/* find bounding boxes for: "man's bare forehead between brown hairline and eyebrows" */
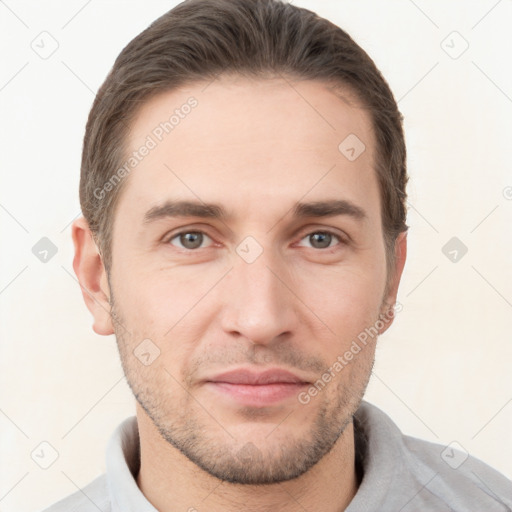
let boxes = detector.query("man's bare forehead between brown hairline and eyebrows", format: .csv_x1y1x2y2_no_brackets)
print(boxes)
118,75,375,222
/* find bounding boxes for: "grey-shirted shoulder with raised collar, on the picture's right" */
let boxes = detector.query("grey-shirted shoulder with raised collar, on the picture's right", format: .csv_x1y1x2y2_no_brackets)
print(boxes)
354,402,512,512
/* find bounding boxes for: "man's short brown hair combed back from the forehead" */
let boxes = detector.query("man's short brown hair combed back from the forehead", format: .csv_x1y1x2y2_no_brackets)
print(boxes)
80,0,408,275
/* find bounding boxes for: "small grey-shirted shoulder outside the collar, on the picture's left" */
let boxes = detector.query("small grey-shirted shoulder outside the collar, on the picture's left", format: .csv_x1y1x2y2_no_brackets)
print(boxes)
42,474,111,512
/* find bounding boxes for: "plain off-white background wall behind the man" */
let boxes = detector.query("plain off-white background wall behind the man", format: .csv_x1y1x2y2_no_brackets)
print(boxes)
0,0,512,512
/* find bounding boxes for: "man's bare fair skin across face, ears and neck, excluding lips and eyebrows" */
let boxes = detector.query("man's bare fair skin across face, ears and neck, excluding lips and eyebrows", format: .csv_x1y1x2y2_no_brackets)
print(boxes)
73,77,406,512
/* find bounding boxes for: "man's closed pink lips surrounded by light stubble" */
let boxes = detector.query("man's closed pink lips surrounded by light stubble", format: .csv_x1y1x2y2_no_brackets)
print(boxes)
204,368,310,407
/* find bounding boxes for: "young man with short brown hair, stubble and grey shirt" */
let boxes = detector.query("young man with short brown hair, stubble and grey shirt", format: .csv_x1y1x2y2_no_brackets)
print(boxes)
44,0,512,512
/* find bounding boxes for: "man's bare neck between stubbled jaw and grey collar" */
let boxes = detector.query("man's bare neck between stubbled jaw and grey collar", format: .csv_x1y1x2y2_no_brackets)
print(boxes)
137,404,358,512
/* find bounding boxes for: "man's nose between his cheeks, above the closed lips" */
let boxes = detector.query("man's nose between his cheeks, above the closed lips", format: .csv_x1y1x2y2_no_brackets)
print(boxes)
221,250,299,345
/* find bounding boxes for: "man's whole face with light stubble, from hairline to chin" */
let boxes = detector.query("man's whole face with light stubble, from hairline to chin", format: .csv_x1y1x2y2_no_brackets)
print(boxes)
102,77,404,484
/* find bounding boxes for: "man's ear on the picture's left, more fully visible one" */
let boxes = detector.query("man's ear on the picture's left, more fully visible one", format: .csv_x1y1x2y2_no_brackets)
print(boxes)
72,217,114,336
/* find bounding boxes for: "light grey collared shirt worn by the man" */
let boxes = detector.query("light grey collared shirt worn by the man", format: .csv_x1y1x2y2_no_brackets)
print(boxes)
44,402,512,512
